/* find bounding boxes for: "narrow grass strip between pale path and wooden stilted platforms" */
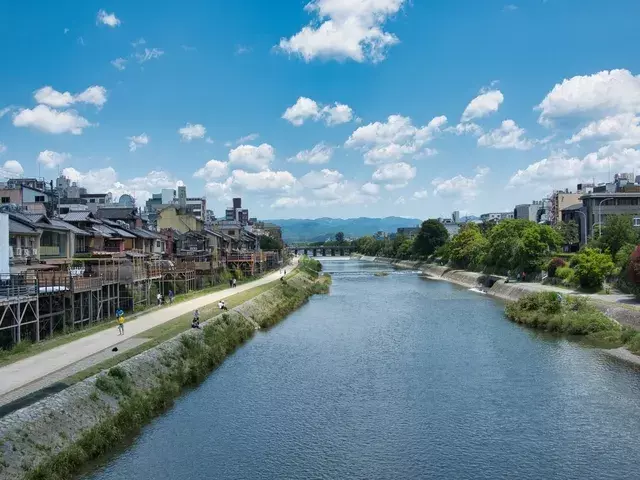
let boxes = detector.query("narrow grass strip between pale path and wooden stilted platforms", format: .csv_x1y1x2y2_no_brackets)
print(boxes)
0,272,282,367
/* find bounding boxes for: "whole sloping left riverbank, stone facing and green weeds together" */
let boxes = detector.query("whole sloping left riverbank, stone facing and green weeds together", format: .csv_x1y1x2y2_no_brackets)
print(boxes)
0,271,330,480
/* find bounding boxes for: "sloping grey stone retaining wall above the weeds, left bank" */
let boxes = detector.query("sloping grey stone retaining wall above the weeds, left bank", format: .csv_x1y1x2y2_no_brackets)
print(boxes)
0,272,324,480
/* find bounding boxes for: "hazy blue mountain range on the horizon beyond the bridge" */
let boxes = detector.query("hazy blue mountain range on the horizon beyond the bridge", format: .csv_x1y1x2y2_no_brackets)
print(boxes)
266,217,422,243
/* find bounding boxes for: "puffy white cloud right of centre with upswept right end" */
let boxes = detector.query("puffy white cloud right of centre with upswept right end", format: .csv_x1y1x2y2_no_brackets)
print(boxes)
345,115,447,165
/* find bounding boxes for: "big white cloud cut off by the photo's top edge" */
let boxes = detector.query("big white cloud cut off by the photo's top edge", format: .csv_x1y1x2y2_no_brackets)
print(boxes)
278,0,405,63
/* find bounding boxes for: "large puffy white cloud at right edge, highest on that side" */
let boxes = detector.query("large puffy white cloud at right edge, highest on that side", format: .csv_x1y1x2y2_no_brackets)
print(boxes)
536,70,640,125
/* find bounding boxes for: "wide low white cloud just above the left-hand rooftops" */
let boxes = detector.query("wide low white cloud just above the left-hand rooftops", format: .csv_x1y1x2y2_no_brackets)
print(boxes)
62,167,183,205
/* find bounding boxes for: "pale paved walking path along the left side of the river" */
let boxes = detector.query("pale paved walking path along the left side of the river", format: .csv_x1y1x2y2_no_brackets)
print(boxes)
0,267,291,397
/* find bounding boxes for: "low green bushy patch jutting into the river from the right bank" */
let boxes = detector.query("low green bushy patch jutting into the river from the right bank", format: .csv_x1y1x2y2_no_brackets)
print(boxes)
505,292,640,354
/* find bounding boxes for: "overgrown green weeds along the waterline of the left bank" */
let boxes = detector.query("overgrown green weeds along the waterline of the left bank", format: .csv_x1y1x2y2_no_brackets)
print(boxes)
24,270,331,480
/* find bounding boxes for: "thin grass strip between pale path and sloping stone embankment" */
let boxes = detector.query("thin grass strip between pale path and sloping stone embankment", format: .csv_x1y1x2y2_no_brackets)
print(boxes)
61,280,280,386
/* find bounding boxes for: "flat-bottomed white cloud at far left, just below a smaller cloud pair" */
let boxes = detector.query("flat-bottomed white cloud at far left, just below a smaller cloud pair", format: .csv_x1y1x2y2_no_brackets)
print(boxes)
13,105,92,135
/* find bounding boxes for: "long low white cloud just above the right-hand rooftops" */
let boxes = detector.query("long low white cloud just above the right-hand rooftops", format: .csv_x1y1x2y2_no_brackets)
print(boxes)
508,146,640,189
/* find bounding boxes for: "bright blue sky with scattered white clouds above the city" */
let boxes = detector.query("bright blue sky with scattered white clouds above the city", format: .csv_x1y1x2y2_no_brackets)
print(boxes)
0,0,640,218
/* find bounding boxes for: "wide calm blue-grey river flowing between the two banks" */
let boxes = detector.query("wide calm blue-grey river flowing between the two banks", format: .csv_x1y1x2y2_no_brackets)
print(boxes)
85,259,640,480
